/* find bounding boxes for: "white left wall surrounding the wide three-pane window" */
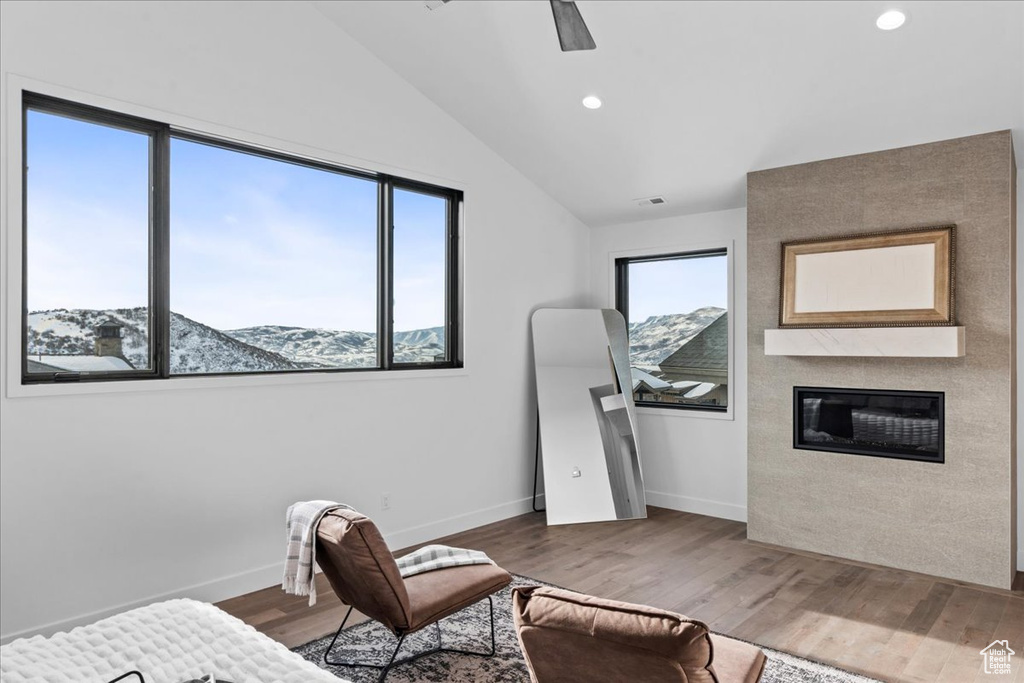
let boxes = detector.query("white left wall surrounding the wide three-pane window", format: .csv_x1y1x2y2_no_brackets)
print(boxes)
0,2,589,640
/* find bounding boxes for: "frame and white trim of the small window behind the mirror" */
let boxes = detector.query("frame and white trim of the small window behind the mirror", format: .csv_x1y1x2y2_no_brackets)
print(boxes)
611,244,735,419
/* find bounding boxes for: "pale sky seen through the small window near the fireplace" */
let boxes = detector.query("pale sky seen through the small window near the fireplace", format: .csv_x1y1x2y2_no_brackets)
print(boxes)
629,256,729,323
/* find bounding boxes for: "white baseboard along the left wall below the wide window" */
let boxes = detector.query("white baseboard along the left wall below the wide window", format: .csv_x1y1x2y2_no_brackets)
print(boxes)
0,496,543,644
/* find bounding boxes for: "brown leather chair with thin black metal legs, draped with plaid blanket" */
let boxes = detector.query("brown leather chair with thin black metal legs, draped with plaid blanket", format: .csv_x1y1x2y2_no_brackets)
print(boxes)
316,509,512,681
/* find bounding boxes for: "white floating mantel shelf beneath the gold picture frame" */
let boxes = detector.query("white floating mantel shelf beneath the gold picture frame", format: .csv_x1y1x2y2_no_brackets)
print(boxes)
765,327,965,358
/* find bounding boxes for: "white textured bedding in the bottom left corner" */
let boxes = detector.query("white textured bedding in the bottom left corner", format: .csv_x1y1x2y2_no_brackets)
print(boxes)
0,600,344,683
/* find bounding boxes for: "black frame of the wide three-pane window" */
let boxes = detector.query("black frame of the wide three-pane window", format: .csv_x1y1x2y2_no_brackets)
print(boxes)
18,89,464,386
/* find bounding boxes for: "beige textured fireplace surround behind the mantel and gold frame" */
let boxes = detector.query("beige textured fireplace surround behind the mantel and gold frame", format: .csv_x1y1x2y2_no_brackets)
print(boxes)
748,131,1016,589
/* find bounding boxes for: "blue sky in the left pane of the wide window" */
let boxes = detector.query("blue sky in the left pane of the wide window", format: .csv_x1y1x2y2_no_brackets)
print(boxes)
27,113,150,317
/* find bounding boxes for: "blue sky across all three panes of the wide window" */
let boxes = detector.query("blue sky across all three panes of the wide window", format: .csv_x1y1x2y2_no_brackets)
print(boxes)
28,112,444,332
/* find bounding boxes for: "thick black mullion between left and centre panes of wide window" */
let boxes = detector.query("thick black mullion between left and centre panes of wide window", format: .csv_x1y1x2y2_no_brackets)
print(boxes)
150,126,171,378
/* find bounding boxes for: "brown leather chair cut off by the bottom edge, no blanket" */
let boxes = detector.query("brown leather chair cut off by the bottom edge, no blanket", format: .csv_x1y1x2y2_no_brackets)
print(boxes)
512,586,765,683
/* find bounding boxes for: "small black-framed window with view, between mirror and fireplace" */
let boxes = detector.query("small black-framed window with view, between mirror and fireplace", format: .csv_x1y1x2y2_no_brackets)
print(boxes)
615,249,729,412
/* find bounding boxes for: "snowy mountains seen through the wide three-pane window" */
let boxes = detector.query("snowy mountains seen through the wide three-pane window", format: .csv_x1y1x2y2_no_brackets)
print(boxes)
29,307,444,374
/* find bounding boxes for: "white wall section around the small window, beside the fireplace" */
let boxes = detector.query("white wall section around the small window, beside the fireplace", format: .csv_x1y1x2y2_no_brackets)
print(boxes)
591,209,746,521
